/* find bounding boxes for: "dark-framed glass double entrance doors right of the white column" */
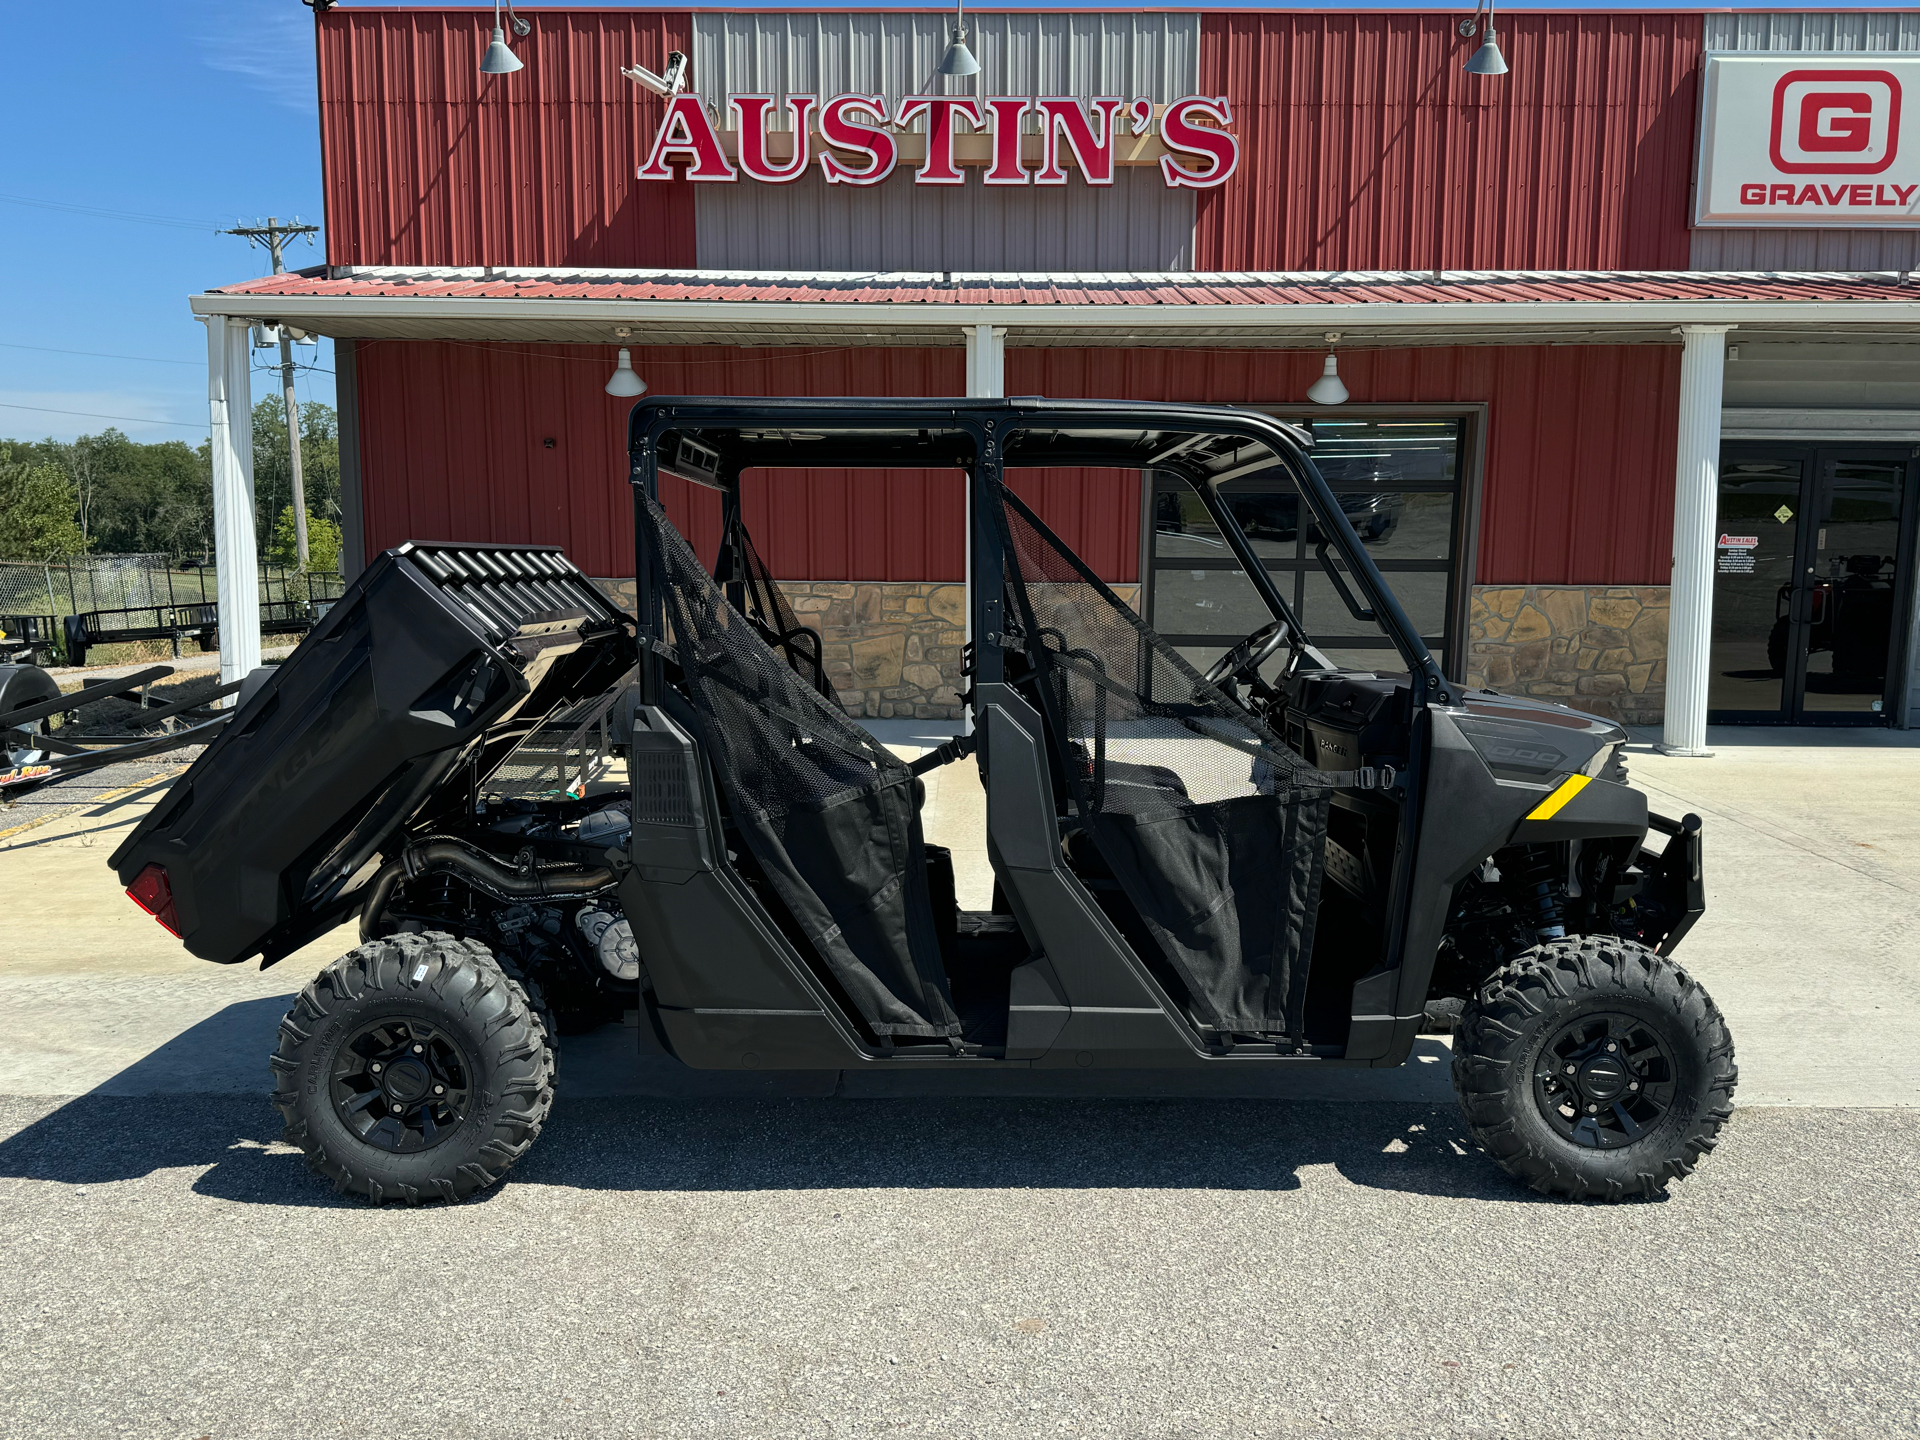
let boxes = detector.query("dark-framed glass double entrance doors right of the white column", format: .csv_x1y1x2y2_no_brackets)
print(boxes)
1708,444,1915,724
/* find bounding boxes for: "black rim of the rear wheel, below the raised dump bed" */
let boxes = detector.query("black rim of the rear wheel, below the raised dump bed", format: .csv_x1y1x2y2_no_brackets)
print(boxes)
332,1016,473,1155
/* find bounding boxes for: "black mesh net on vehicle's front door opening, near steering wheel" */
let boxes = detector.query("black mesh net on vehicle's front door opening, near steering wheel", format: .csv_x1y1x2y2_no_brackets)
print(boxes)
1001,490,1331,1043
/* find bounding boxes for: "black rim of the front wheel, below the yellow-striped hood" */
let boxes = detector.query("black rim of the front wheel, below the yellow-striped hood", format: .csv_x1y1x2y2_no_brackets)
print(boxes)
1535,1013,1675,1151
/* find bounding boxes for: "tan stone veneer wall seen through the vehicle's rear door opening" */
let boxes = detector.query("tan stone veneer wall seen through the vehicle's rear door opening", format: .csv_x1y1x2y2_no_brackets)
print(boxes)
594,580,1139,721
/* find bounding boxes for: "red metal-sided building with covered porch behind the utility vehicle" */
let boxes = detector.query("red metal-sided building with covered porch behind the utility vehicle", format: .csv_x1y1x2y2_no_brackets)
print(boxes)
196,6,1921,747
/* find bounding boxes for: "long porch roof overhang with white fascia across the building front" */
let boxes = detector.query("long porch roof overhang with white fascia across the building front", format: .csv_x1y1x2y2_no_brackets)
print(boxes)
192,290,1917,350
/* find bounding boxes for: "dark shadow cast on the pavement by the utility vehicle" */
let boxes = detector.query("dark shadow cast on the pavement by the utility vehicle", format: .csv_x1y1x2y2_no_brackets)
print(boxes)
0,997,1598,1207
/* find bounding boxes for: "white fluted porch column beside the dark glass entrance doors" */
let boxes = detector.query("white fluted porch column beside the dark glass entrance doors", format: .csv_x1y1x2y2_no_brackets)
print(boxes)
1660,325,1733,755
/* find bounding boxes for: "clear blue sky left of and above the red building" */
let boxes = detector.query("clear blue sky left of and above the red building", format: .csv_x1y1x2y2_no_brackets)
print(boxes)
0,0,1877,442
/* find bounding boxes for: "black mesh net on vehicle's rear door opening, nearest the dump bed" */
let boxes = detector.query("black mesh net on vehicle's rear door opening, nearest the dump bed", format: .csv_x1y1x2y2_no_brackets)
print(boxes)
638,496,961,1038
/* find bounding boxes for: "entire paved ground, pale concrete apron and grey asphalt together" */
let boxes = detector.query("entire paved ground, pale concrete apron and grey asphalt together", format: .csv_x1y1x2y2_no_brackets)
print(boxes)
0,732,1921,1435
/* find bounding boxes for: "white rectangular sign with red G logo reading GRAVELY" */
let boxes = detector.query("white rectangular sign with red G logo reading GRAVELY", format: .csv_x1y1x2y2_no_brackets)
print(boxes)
1694,52,1921,231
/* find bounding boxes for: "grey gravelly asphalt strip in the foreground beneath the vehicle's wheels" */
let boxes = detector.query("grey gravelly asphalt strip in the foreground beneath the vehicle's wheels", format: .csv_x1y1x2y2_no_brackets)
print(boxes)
0,1095,1921,1437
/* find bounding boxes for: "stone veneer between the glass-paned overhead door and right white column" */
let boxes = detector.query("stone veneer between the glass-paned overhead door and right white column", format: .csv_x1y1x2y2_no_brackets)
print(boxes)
1466,586,1667,726
